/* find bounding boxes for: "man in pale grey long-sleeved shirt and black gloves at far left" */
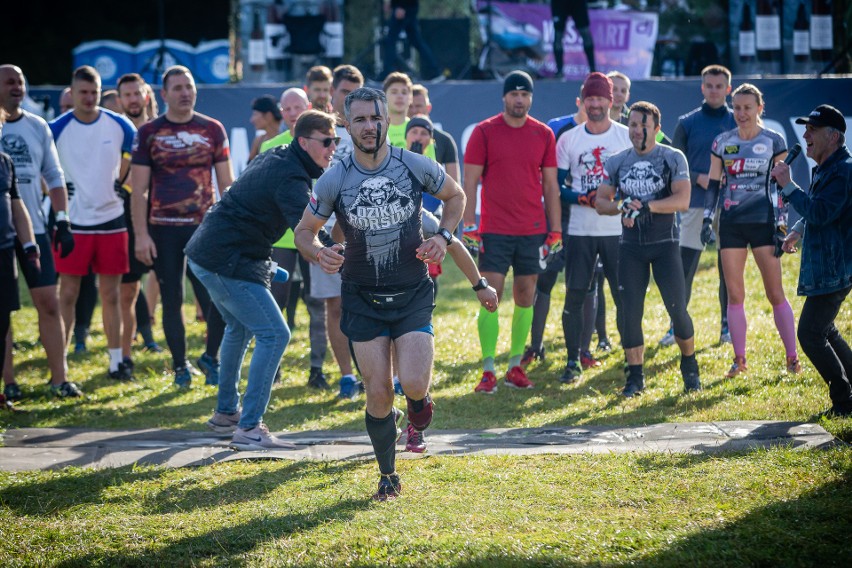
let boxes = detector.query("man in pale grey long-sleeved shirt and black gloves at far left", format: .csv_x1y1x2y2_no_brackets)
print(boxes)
0,65,80,401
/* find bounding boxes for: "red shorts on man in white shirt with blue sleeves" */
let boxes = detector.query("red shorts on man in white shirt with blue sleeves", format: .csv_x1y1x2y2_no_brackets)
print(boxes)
53,231,130,276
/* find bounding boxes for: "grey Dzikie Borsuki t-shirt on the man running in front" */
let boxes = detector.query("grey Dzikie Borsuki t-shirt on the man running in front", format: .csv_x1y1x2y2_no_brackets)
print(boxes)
310,147,446,288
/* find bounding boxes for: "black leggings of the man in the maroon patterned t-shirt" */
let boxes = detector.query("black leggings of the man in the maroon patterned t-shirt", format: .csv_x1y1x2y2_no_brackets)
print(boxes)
148,225,225,368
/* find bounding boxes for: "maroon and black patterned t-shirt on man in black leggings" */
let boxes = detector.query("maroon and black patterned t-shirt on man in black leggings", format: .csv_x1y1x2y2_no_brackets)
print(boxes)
132,113,230,226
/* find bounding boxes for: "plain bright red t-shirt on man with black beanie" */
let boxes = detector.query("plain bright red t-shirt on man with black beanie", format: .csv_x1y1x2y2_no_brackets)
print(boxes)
464,114,556,236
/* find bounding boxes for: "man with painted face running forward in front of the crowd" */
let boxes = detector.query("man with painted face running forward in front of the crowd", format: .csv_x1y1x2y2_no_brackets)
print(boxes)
296,88,465,501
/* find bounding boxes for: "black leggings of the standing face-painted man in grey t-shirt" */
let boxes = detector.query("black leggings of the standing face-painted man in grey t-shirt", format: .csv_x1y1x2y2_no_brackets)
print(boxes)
618,242,695,349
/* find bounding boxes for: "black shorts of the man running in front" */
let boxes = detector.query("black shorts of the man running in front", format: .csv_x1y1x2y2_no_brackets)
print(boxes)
340,278,435,342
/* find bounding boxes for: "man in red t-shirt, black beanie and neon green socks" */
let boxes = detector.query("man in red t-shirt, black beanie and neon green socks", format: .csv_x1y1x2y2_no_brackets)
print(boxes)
464,71,562,394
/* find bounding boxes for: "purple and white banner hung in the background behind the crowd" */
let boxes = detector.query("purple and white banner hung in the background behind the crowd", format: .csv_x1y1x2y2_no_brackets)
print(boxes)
477,0,659,79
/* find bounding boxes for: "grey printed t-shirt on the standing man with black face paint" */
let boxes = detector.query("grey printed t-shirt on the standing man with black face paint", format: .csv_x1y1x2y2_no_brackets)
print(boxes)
604,144,689,244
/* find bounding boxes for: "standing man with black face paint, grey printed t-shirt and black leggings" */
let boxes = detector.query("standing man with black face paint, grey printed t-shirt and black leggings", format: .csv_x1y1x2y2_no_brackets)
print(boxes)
595,102,701,397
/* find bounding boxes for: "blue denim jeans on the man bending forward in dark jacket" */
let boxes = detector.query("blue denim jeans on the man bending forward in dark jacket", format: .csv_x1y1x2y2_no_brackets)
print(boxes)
189,260,290,430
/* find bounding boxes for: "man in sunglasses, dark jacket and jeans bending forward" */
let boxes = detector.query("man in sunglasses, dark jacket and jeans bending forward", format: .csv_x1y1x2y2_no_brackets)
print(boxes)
186,110,340,450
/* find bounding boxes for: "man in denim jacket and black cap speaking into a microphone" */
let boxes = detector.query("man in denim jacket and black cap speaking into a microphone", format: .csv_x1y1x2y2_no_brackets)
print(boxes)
770,105,852,416
